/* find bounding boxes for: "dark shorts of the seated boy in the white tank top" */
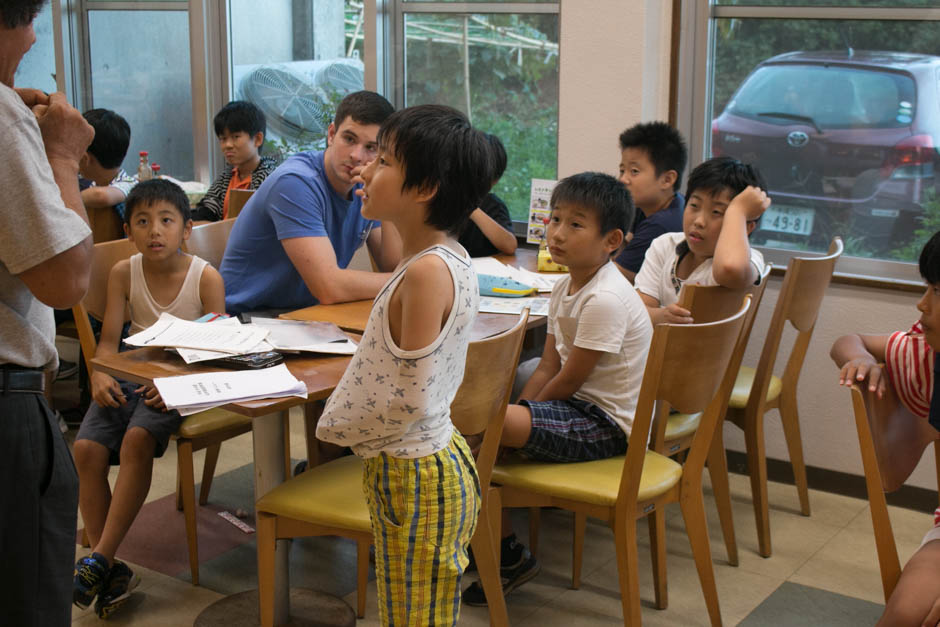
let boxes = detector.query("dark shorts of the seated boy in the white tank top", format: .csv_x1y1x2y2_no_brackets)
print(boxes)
75,381,183,465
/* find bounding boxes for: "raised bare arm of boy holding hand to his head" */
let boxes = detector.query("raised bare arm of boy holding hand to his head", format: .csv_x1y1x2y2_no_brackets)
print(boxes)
712,186,770,289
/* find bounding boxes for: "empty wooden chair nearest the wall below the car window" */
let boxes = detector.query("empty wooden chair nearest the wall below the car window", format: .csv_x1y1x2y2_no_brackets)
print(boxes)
725,237,842,557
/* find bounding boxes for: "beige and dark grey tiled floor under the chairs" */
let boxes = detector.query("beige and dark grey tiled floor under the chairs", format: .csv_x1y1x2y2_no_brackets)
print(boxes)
53,338,931,627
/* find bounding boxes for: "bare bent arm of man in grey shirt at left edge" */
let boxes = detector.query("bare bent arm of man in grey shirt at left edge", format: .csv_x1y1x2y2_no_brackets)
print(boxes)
19,94,95,309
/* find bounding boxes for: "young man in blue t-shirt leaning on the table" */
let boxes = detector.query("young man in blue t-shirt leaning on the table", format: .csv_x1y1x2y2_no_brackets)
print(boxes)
220,91,401,314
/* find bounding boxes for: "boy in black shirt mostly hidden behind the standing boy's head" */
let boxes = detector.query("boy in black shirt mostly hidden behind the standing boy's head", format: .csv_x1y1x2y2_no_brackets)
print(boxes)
457,133,516,257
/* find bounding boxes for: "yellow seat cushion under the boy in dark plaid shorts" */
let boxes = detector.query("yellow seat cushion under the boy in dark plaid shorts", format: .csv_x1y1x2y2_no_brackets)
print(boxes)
492,451,682,505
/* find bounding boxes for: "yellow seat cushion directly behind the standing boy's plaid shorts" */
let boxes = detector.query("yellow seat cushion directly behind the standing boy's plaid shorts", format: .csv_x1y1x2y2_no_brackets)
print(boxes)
255,455,372,532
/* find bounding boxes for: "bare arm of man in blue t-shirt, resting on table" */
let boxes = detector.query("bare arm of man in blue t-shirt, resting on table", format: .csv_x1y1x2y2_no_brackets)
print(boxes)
281,233,397,305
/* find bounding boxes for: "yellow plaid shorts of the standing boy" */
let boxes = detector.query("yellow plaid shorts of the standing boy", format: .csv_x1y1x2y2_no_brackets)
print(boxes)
362,431,480,626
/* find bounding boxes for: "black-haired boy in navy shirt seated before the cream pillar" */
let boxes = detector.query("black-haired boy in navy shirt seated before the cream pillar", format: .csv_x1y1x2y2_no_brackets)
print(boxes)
614,122,689,283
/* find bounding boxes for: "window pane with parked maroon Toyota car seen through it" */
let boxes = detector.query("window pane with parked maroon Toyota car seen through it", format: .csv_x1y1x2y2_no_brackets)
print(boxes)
711,18,940,261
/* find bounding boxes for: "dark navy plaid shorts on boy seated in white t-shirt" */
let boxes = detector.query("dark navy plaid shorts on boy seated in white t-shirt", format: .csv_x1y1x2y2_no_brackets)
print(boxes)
519,398,627,462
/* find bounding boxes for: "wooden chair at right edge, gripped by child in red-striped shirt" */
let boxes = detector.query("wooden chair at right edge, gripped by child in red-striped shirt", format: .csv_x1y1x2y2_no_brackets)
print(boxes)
852,381,940,603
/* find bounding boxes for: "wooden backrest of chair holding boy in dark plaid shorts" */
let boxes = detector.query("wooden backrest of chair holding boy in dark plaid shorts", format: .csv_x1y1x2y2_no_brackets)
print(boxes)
618,295,751,507
